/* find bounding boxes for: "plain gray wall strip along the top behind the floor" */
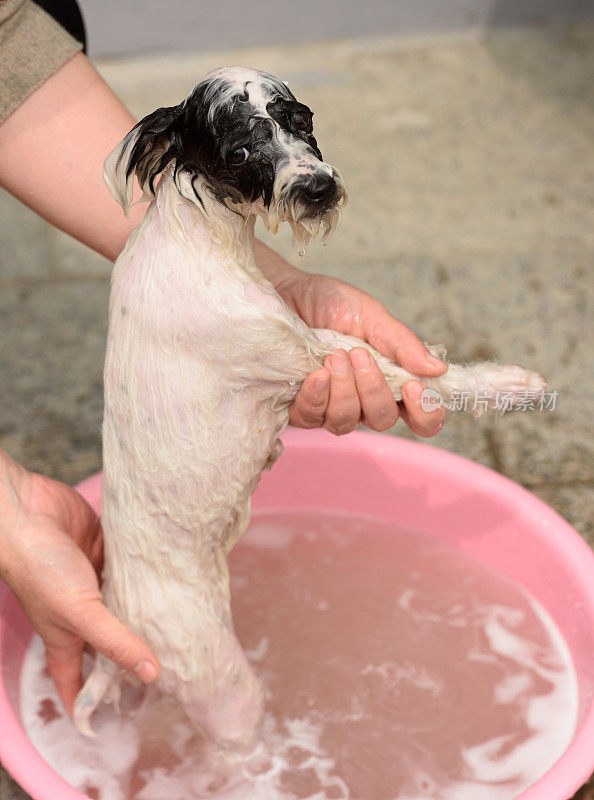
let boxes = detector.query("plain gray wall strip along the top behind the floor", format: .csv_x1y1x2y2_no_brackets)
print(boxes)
79,0,594,56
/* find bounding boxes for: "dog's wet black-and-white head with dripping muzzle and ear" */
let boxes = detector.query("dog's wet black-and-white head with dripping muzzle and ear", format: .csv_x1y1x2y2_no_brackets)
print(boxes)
105,67,346,246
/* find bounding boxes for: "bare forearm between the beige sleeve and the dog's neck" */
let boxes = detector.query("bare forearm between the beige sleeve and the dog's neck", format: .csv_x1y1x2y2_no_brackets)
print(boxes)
0,54,138,260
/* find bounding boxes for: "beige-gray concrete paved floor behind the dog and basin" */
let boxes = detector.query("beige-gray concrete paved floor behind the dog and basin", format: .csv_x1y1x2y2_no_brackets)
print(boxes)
0,24,594,800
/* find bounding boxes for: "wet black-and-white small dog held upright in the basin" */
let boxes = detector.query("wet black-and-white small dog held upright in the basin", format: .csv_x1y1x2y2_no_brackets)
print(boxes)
74,67,545,745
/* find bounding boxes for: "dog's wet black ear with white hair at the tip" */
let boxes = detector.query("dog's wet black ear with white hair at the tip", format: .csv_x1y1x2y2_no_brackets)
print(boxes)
103,105,184,216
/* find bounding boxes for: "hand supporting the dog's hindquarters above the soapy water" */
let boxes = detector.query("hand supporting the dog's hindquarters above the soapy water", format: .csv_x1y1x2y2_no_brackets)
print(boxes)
0,451,159,714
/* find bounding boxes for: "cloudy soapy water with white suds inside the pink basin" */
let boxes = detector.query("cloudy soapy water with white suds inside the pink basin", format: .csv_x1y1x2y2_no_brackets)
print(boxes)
21,512,577,800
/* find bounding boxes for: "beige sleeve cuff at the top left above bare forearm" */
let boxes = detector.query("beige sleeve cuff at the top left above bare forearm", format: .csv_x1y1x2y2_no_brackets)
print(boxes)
0,0,82,122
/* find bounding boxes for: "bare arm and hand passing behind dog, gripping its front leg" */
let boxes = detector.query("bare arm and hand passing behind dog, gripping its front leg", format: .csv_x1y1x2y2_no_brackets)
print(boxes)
0,54,446,436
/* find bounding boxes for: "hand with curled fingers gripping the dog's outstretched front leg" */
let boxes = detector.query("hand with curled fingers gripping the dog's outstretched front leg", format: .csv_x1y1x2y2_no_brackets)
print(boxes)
276,269,447,436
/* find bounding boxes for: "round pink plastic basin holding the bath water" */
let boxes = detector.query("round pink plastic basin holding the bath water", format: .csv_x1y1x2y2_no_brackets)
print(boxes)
0,430,594,800
